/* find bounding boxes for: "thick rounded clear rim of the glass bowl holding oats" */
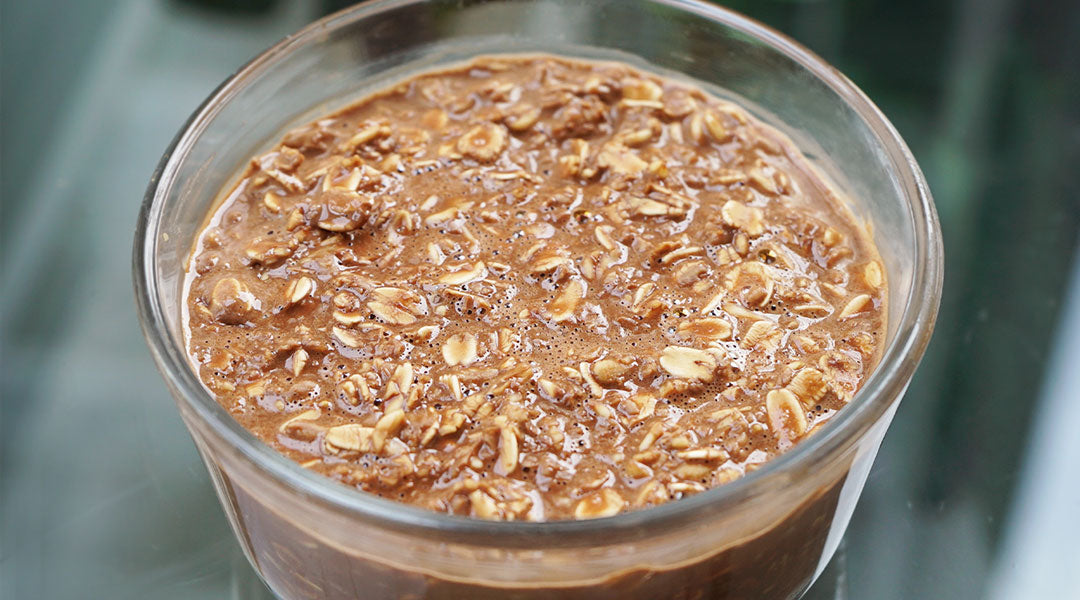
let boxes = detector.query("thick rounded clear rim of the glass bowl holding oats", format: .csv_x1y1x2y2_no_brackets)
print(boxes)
133,0,943,546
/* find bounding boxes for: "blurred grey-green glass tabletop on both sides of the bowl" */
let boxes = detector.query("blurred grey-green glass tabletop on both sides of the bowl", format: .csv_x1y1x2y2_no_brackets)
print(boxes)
0,0,1080,600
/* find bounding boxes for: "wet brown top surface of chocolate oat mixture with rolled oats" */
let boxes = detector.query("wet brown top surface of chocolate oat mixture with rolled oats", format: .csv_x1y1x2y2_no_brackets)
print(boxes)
187,57,885,520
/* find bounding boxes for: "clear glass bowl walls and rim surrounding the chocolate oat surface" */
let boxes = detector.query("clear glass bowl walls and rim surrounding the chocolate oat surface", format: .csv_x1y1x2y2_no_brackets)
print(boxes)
134,0,942,600
